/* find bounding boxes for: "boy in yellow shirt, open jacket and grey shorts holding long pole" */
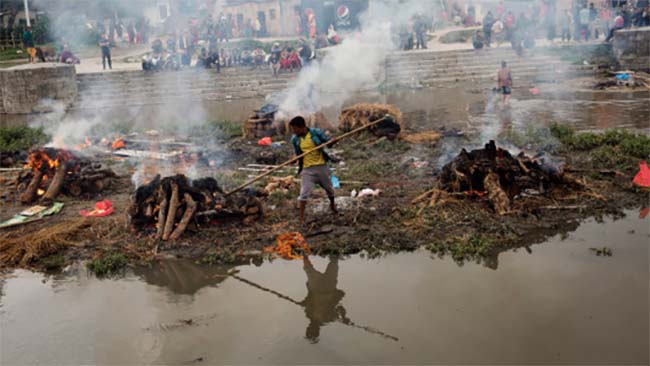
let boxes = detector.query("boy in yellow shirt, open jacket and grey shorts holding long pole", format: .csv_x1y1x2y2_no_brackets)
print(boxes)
289,116,338,225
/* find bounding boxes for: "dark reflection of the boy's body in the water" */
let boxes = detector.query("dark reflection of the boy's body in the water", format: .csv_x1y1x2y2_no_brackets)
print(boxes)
300,256,346,343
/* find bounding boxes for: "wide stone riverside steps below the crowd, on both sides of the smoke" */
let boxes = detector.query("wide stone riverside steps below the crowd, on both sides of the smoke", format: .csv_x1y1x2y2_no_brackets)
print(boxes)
72,48,594,109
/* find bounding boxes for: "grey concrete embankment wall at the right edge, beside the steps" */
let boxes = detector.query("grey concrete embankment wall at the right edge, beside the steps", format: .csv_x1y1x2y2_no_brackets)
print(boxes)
613,27,650,72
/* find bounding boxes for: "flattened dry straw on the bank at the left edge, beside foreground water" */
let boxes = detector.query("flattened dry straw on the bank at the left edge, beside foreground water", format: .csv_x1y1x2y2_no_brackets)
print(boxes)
0,219,91,266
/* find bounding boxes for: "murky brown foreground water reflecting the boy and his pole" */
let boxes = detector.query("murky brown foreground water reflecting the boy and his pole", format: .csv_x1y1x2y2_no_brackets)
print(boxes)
0,211,650,365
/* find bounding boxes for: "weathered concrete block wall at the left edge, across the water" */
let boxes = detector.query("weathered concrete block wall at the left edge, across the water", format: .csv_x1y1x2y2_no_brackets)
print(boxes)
0,63,77,114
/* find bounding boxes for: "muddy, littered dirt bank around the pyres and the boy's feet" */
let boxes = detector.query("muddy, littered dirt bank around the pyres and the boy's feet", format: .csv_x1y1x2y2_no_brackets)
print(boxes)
0,121,650,270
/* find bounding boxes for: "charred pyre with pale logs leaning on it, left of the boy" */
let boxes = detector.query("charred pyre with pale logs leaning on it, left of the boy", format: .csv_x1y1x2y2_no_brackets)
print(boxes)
128,174,264,241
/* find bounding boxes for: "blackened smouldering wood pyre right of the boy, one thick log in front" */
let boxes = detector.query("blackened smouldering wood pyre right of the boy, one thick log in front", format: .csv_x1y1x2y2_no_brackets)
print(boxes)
413,141,599,215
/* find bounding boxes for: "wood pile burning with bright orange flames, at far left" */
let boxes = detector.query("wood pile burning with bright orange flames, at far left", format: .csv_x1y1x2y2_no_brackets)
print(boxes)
16,148,117,204
